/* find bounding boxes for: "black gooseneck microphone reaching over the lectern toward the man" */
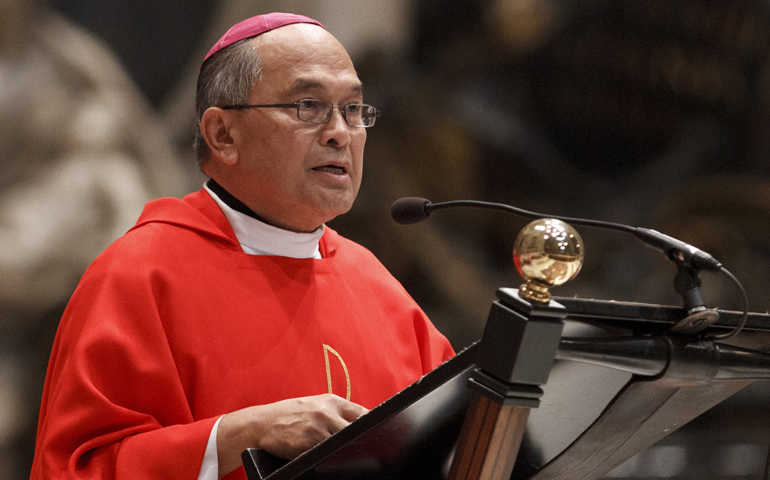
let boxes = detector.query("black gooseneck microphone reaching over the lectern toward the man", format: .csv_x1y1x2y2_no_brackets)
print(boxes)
390,197,722,271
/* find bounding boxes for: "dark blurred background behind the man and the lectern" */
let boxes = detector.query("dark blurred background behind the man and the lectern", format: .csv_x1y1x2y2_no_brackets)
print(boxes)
0,0,770,479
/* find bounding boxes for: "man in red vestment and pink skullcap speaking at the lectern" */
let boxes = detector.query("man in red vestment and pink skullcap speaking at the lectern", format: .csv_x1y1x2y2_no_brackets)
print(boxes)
32,14,453,479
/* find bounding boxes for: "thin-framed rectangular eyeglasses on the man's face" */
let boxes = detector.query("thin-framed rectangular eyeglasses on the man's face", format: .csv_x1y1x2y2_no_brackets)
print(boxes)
221,100,381,128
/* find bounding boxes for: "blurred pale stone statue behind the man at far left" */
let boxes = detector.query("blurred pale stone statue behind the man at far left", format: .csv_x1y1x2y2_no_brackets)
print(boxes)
0,0,192,478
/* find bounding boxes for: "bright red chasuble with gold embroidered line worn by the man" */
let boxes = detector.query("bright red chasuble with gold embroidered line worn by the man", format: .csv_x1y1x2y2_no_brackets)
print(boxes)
31,191,453,480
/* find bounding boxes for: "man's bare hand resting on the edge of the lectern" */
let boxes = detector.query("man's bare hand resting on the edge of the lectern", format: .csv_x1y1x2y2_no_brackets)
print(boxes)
217,394,368,478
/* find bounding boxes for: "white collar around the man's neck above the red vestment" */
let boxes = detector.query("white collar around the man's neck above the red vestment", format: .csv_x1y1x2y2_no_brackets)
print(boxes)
203,185,325,258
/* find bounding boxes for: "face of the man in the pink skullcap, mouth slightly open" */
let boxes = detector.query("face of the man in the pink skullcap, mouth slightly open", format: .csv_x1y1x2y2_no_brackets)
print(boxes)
222,24,366,231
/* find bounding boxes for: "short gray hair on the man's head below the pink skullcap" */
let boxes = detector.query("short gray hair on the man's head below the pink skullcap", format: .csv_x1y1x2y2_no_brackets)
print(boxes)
193,38,262,168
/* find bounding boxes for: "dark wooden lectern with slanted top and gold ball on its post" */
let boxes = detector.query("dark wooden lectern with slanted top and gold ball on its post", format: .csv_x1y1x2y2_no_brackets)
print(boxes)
242,219,770,480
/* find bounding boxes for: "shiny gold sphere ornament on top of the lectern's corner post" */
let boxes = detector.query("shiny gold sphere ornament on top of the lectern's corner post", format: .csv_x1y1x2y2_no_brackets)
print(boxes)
513,218,585,303
